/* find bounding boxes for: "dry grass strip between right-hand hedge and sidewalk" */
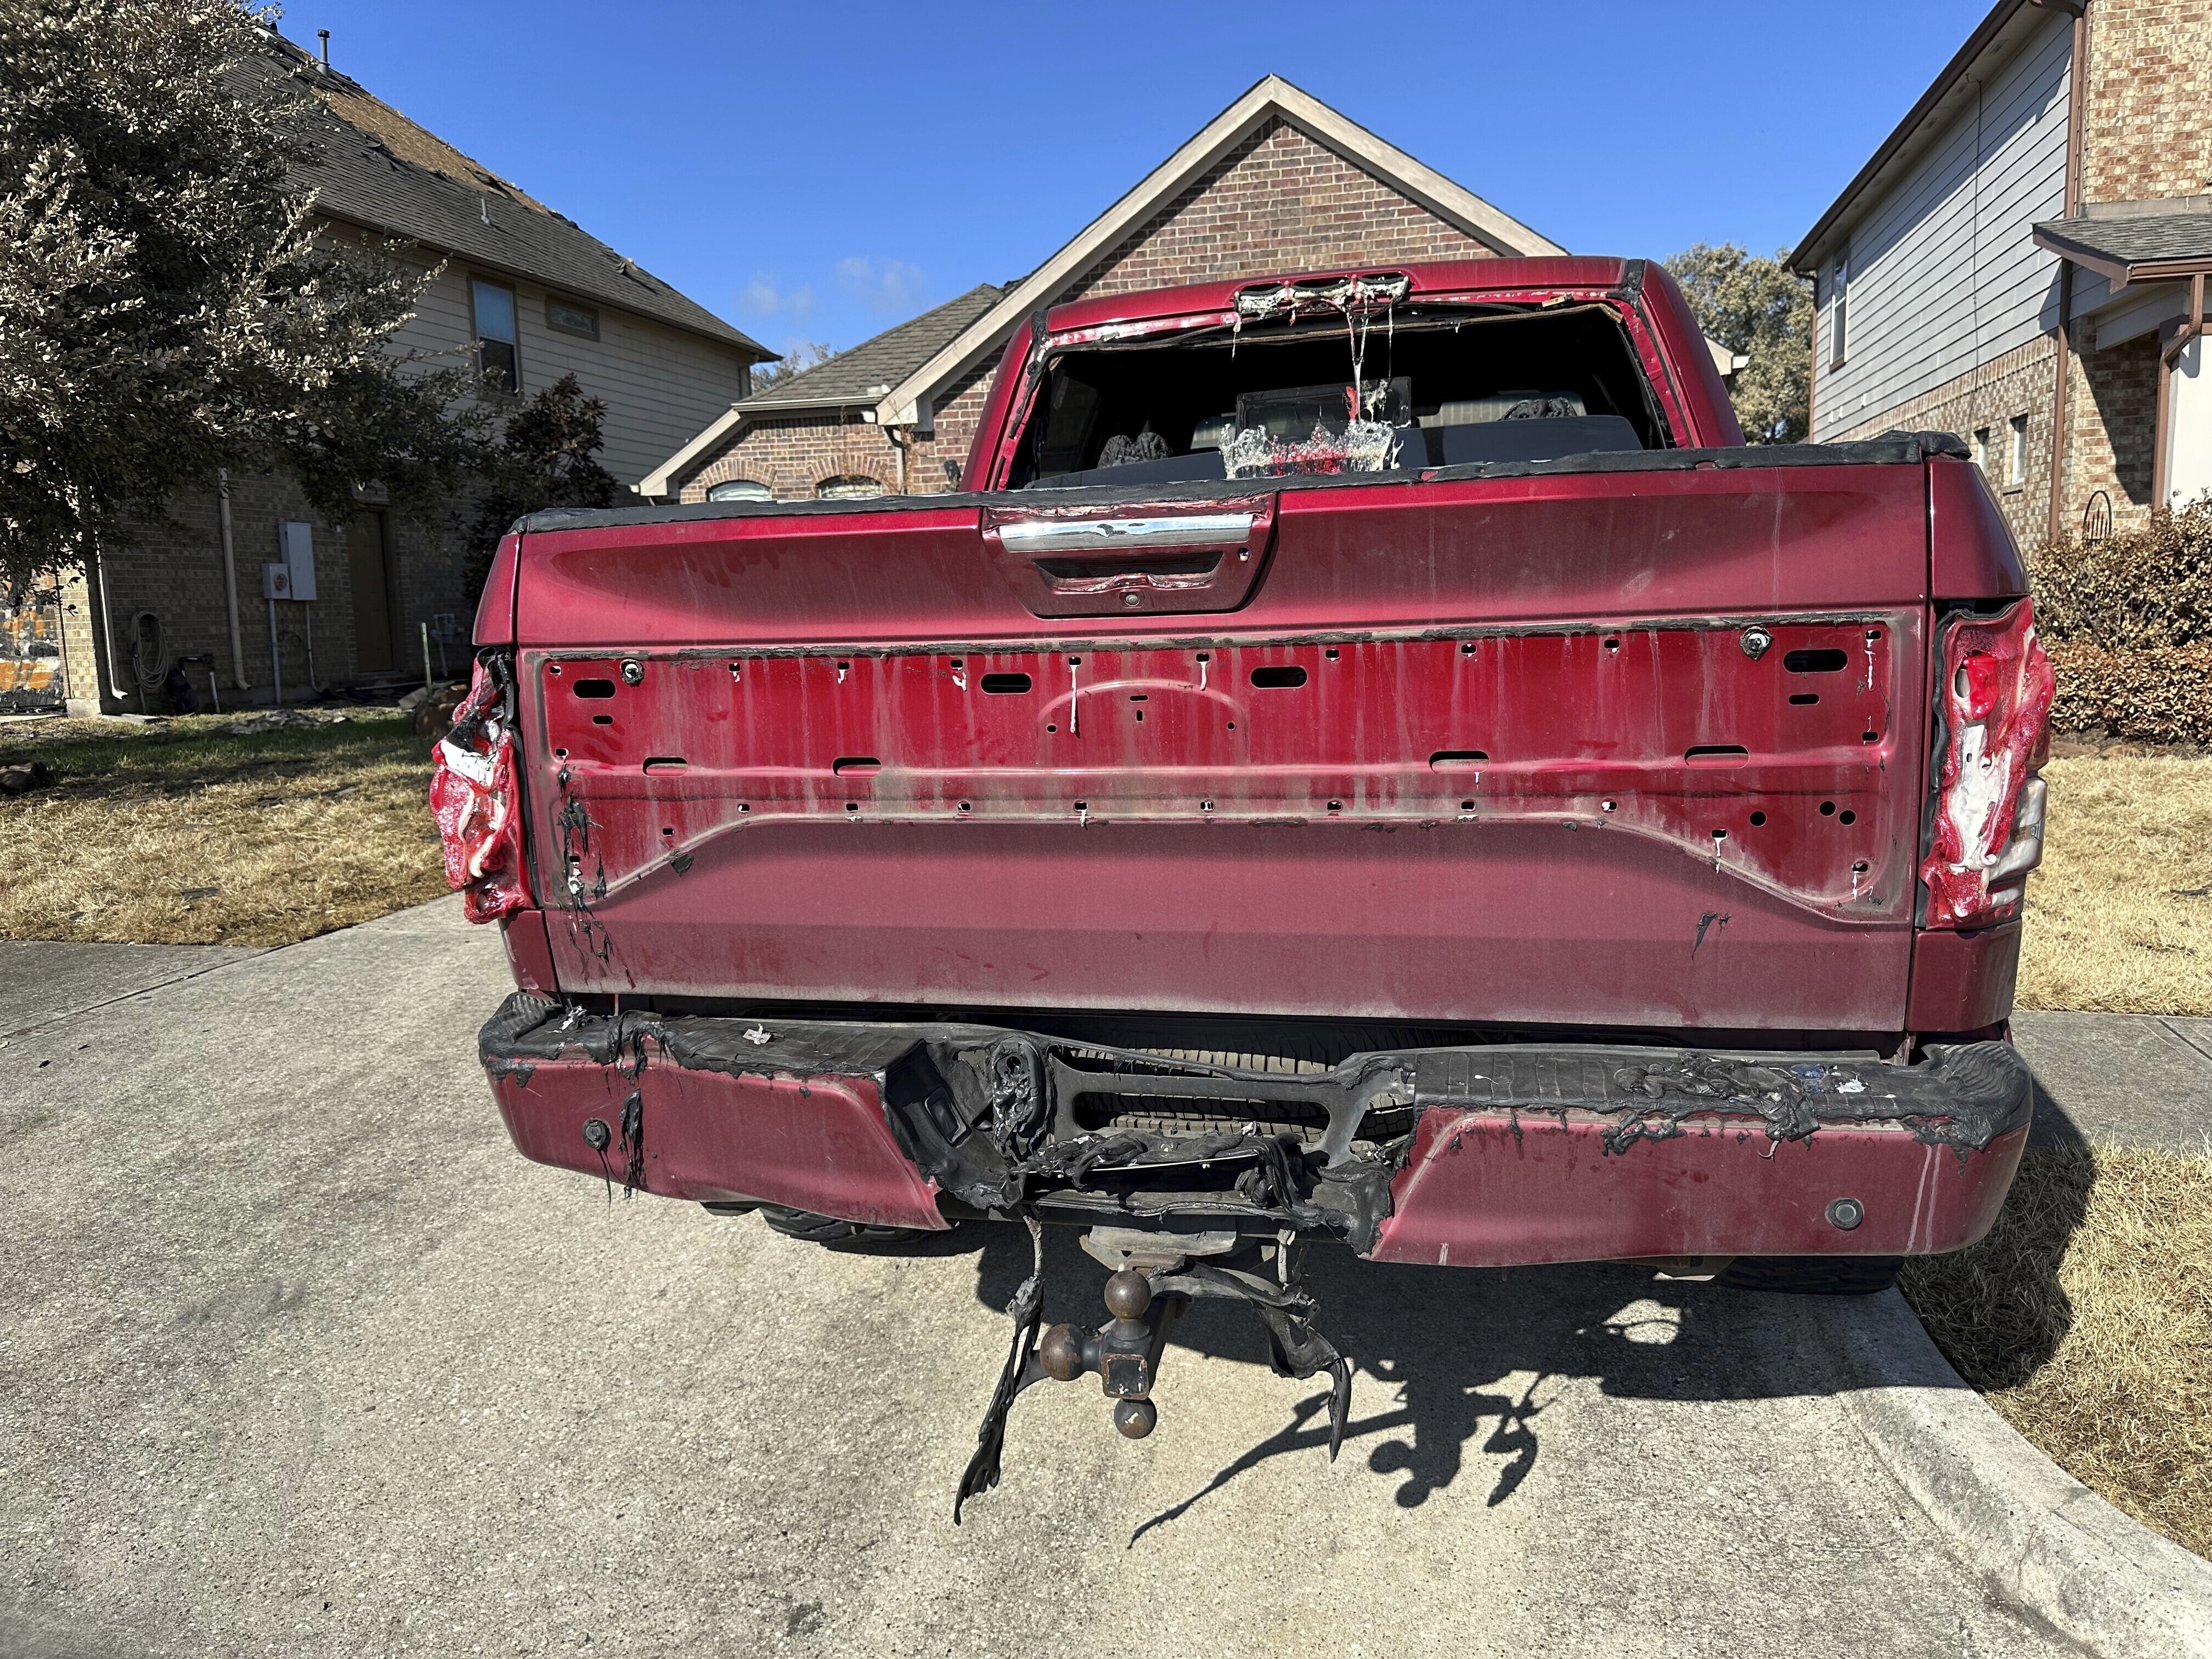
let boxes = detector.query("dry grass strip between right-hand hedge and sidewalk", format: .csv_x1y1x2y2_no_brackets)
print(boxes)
2019,757,2212,1013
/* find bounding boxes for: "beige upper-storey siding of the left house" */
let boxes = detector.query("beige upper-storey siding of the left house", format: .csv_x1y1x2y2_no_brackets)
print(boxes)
380,259,746,487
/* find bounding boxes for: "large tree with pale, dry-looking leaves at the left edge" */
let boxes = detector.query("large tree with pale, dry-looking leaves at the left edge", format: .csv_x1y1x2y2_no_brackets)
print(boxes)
0,0,482,593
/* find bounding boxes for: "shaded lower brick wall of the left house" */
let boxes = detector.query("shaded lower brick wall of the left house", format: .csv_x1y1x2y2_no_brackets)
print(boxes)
64,473,471,712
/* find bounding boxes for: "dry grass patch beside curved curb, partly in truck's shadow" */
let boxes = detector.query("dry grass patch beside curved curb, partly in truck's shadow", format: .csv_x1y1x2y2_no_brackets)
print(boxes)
1903,1146,2212,1555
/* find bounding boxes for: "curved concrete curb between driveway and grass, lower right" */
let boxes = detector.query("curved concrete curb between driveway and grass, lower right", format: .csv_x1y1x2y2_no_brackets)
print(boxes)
1814,1290,2212,1659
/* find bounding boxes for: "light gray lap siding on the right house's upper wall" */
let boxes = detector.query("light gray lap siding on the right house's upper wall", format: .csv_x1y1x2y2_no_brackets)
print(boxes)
1814,11,2073,438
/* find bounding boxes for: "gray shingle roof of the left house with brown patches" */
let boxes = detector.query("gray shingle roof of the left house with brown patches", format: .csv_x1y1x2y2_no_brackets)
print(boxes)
239,29,776,363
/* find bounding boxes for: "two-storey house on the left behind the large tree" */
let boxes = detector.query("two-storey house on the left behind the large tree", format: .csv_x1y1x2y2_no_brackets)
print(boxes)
37,33,774,712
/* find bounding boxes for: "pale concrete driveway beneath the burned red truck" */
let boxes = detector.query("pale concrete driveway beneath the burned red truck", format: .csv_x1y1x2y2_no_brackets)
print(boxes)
0,902,2073,1659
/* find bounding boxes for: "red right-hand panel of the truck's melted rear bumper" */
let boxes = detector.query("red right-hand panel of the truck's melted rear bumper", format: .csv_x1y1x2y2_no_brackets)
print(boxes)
1372,1110,2028,1267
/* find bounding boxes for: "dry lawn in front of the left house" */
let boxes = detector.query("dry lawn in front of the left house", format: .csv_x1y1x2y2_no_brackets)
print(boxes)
0,710,444,945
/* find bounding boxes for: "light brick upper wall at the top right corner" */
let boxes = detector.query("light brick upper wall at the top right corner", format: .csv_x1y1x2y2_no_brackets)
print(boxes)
2081,0,2212,201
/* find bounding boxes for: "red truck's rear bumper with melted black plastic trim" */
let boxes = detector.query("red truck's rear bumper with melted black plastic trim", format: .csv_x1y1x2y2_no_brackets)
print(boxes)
482,993,2030,1265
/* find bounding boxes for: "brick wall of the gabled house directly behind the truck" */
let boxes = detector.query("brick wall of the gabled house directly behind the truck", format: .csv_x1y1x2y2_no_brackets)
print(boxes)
681,122,1493,502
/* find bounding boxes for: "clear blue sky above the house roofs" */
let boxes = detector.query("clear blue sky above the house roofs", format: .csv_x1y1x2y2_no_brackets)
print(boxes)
283,0,1987,363
